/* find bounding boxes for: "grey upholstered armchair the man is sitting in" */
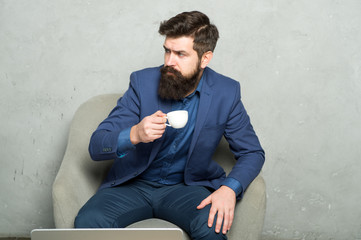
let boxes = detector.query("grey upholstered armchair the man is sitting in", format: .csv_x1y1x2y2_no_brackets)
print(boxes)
53,94,266,240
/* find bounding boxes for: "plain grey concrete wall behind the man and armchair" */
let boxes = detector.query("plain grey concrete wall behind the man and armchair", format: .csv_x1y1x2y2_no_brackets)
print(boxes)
0,0,361,239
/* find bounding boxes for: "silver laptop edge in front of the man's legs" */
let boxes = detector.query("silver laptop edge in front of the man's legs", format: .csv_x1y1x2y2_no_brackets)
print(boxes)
31,228,183,240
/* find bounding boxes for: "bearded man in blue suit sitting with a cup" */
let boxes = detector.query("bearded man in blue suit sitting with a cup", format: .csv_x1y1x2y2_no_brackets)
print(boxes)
75,11,264,240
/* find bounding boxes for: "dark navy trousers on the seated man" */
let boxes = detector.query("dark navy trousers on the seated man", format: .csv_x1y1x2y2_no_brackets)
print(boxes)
74,180,227,240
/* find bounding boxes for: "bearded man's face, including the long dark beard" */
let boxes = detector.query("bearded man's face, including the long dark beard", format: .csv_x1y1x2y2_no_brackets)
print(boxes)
158,37,202,100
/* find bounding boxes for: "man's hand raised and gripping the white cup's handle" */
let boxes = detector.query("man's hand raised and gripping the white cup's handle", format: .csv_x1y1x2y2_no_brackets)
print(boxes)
130,110,167,145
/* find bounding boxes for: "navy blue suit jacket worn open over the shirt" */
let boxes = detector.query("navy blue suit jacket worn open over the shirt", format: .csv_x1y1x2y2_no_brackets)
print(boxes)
89,67,264,197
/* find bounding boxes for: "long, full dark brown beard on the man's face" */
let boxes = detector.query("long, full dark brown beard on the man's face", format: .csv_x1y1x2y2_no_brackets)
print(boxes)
158,63,202,100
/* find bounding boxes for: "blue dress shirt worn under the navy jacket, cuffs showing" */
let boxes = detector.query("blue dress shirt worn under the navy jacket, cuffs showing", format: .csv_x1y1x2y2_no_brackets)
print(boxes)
117,76,242,196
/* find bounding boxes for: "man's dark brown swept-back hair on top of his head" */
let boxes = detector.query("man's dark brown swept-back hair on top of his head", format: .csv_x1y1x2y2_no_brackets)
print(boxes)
158,11,219,58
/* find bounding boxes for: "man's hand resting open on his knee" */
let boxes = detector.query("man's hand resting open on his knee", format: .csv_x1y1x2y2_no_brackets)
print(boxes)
197,186,236,234
